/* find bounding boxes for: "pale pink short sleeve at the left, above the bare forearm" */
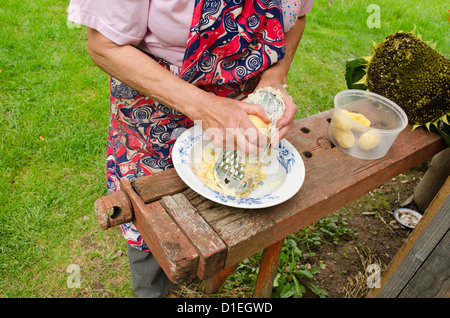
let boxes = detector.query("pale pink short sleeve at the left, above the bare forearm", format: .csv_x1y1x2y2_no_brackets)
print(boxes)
68,0,150,45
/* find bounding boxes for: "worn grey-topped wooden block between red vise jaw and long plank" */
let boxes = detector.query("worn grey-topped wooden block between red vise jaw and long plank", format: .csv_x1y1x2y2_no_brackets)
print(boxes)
160,193,227,279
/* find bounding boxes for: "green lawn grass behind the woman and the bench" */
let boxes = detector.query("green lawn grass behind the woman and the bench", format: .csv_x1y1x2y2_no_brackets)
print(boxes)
0,0,450,297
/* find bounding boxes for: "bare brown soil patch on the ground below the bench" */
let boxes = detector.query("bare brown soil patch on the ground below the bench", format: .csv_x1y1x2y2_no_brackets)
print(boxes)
286,163,427,298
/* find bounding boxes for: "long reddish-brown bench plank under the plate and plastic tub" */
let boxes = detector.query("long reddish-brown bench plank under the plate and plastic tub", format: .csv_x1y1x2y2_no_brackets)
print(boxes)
185,112,446,268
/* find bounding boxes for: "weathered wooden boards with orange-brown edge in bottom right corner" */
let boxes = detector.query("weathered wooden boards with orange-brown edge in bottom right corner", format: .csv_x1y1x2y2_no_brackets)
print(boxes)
368,177,450,298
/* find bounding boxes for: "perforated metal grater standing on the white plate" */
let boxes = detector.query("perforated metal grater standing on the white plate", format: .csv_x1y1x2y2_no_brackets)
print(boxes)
214,150,253,194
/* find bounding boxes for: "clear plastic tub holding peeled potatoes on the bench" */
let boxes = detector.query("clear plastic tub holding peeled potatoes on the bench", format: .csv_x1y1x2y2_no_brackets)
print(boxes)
329,90,408,160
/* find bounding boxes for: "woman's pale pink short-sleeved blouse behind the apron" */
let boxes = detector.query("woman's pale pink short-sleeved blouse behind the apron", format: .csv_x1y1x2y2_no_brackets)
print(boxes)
68,0,314,66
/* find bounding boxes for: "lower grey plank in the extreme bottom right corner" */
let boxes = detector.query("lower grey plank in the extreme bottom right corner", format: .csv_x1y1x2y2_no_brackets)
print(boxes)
398,229,450,298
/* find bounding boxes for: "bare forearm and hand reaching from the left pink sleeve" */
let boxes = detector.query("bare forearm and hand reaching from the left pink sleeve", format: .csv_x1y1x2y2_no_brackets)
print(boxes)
88,29,269,154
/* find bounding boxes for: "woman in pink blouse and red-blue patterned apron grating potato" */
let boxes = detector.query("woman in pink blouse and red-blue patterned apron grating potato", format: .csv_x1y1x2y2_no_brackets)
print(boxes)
69,0,313,297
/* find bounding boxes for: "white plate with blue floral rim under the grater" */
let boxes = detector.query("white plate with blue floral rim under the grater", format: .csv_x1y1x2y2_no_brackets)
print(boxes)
172,125,305,209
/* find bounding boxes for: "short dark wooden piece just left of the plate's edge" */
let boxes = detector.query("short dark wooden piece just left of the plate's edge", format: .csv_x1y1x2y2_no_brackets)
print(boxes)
131,169,187,203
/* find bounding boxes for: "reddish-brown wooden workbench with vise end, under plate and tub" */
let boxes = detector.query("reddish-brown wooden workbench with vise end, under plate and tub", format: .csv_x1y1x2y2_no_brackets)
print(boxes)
95,111,446,297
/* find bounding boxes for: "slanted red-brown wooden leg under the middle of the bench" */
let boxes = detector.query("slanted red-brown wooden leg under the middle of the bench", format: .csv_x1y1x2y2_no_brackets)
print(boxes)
253,239,284,298
